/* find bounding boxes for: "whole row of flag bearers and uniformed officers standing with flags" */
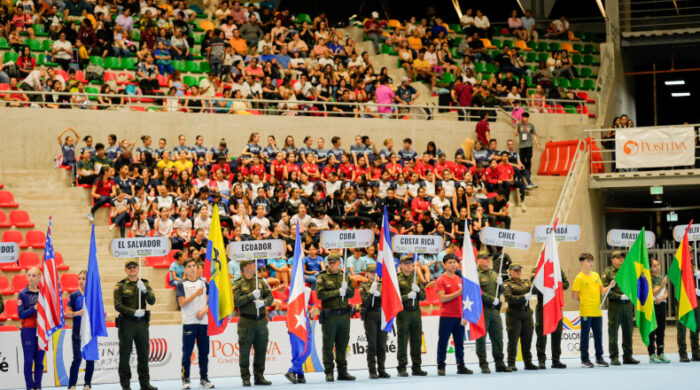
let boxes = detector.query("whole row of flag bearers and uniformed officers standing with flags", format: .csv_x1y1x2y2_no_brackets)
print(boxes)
12,210,700,390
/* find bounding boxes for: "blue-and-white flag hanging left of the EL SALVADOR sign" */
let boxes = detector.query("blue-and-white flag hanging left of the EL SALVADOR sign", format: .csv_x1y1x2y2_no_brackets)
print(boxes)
80,224,107,360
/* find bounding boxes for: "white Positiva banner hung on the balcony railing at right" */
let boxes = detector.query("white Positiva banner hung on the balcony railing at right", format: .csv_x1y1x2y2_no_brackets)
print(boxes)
615,126,695,168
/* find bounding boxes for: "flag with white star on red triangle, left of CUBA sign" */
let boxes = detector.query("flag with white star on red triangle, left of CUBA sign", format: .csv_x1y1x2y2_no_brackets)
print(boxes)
287,222,311,374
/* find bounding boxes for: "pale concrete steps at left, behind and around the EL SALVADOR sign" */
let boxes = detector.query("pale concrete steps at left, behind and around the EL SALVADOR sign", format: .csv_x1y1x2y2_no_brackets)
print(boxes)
3,165,181,324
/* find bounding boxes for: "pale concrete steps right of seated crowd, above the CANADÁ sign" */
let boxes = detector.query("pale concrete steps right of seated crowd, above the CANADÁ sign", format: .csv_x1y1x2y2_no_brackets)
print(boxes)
506,176,566,266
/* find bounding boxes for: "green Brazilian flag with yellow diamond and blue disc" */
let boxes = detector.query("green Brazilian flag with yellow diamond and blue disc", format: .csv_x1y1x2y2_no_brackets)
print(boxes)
615,228,656,346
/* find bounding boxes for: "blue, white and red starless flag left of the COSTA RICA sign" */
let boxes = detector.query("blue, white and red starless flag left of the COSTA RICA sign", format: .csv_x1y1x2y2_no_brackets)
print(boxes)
377,206,403,332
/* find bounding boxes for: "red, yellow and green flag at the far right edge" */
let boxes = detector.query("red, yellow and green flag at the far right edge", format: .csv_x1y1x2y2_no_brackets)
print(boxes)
668,221,698,332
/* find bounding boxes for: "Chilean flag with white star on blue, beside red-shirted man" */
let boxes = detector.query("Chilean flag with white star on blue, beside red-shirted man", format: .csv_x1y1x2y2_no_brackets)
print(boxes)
462,221,486,340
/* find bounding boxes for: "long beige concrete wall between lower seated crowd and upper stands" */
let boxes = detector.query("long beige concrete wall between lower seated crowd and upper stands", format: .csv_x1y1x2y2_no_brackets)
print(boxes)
0,108,590,169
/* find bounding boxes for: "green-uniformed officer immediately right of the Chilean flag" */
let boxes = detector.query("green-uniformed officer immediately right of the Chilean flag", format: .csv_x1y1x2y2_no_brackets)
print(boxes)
476,253,510,374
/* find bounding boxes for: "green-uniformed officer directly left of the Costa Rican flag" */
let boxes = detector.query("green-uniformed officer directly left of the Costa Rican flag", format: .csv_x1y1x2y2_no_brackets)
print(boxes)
360,264,391,379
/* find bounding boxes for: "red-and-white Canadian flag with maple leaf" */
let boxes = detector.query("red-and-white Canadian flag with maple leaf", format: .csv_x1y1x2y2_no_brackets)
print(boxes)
534,219,564,335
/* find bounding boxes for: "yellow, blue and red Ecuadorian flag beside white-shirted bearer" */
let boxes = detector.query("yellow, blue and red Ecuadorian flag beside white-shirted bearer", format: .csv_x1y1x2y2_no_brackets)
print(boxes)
204,206,233,336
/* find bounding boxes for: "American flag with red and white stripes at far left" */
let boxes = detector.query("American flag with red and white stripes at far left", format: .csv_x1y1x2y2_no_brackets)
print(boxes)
37,217,66,351
